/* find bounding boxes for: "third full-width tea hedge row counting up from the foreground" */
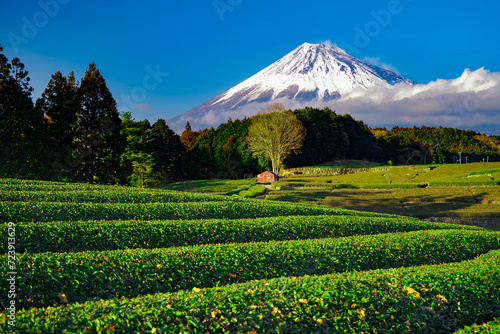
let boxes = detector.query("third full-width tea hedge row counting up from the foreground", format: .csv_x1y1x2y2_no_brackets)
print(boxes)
0,215,483,254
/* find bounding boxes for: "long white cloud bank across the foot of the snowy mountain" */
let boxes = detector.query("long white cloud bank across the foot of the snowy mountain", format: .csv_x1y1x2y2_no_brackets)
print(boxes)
172,68,500,134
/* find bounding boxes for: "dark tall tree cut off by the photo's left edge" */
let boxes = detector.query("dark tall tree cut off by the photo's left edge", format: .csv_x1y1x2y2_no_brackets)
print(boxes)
0,45,50,179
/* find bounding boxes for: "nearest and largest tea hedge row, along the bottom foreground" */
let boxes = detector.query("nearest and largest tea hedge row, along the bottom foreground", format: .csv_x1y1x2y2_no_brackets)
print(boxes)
4,251,500,333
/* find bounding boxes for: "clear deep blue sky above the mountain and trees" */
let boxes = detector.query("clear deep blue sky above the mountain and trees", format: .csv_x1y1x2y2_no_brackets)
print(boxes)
0,0,500,130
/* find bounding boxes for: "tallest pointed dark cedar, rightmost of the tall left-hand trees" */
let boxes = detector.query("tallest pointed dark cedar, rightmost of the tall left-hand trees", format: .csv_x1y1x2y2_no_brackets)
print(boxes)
74,62,131,184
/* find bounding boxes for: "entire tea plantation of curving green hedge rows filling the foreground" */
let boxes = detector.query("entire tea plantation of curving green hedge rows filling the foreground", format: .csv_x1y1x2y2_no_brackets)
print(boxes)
0,179,500,333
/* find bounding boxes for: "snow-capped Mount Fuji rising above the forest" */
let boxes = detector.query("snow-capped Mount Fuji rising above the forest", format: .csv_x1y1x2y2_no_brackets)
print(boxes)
168,43,416,131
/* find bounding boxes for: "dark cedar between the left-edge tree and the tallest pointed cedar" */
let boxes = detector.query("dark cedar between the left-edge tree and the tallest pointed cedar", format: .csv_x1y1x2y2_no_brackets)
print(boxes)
35,71,80,181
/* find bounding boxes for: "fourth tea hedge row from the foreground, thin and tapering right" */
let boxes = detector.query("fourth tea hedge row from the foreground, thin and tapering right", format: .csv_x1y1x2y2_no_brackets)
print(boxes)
0,197,395,222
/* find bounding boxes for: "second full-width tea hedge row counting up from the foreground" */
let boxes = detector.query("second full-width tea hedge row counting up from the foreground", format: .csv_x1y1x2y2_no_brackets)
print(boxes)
0,230,500,307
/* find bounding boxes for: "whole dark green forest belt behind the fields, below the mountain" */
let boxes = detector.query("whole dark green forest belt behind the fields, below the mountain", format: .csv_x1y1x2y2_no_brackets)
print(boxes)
0,46,500,187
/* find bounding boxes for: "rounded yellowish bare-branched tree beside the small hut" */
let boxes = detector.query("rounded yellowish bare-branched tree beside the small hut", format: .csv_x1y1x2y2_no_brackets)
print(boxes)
247,106,306,174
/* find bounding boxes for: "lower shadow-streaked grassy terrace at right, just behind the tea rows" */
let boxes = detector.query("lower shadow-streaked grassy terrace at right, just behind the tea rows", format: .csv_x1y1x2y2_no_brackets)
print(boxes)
266,187,500,218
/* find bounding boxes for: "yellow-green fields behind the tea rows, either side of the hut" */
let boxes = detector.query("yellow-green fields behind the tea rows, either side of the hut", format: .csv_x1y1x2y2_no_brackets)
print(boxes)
165,163,500,222
